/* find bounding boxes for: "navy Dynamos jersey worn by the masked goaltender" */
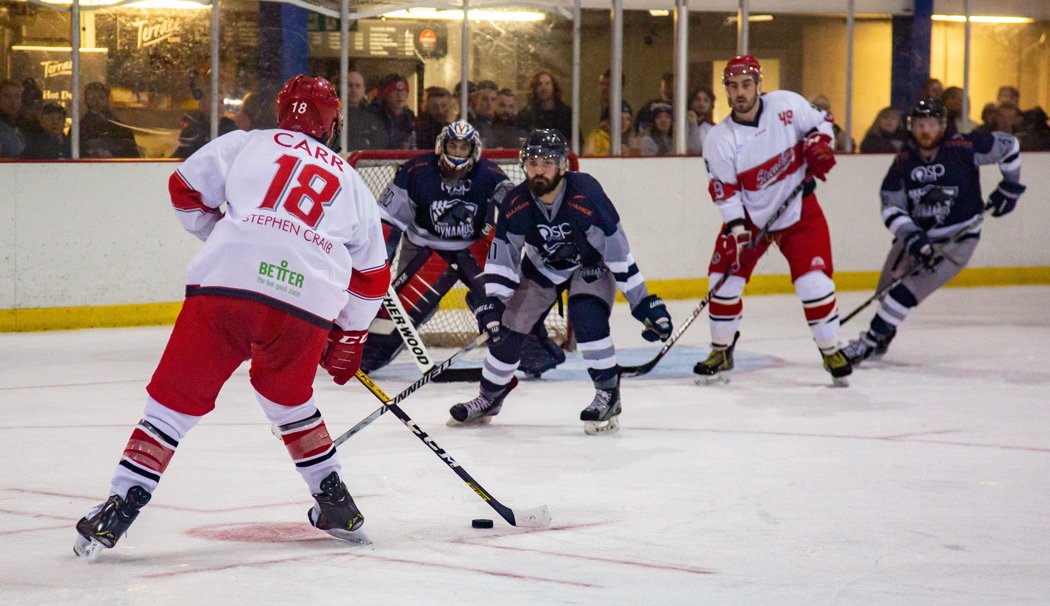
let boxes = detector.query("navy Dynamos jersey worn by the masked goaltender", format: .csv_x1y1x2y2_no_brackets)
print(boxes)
379,153,512,250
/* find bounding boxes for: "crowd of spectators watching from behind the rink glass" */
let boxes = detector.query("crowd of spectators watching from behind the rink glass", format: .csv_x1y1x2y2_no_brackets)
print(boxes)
0,69,1050,160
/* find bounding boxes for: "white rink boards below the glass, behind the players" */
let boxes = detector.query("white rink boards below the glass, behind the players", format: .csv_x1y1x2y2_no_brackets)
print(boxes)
0,153,1050,309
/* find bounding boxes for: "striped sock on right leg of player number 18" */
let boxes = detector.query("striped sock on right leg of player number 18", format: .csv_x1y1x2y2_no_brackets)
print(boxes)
255,392,340,494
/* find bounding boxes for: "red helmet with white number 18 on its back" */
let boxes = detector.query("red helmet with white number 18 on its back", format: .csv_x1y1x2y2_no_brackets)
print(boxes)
277,74,341,145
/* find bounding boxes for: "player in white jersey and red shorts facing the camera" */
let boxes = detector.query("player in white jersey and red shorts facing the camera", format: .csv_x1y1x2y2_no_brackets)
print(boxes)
693,55,853,384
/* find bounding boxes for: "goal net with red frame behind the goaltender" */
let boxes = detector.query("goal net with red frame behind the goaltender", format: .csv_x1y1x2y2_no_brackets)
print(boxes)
347,149,579,349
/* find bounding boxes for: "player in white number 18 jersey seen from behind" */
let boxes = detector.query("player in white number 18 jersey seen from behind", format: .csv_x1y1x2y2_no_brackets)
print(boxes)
74,76,390,558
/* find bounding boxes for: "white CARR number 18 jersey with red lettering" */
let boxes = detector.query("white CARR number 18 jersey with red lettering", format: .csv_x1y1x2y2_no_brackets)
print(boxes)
169,129,390,330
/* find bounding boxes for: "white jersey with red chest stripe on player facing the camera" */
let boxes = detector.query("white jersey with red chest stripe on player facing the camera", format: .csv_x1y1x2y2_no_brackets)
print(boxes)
704,90,833,231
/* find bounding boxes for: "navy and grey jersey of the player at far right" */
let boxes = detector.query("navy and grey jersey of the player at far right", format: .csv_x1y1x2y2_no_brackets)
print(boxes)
882,131,1021,242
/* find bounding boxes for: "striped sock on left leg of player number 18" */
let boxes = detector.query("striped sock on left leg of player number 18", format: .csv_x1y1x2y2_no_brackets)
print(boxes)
109,397,201,497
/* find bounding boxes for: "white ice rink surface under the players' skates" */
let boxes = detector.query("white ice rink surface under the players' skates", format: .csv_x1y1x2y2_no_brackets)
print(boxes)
0,287,1050,605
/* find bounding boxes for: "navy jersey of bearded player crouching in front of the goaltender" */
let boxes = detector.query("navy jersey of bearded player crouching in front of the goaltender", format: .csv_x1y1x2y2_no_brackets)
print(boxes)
485,172,649,308
